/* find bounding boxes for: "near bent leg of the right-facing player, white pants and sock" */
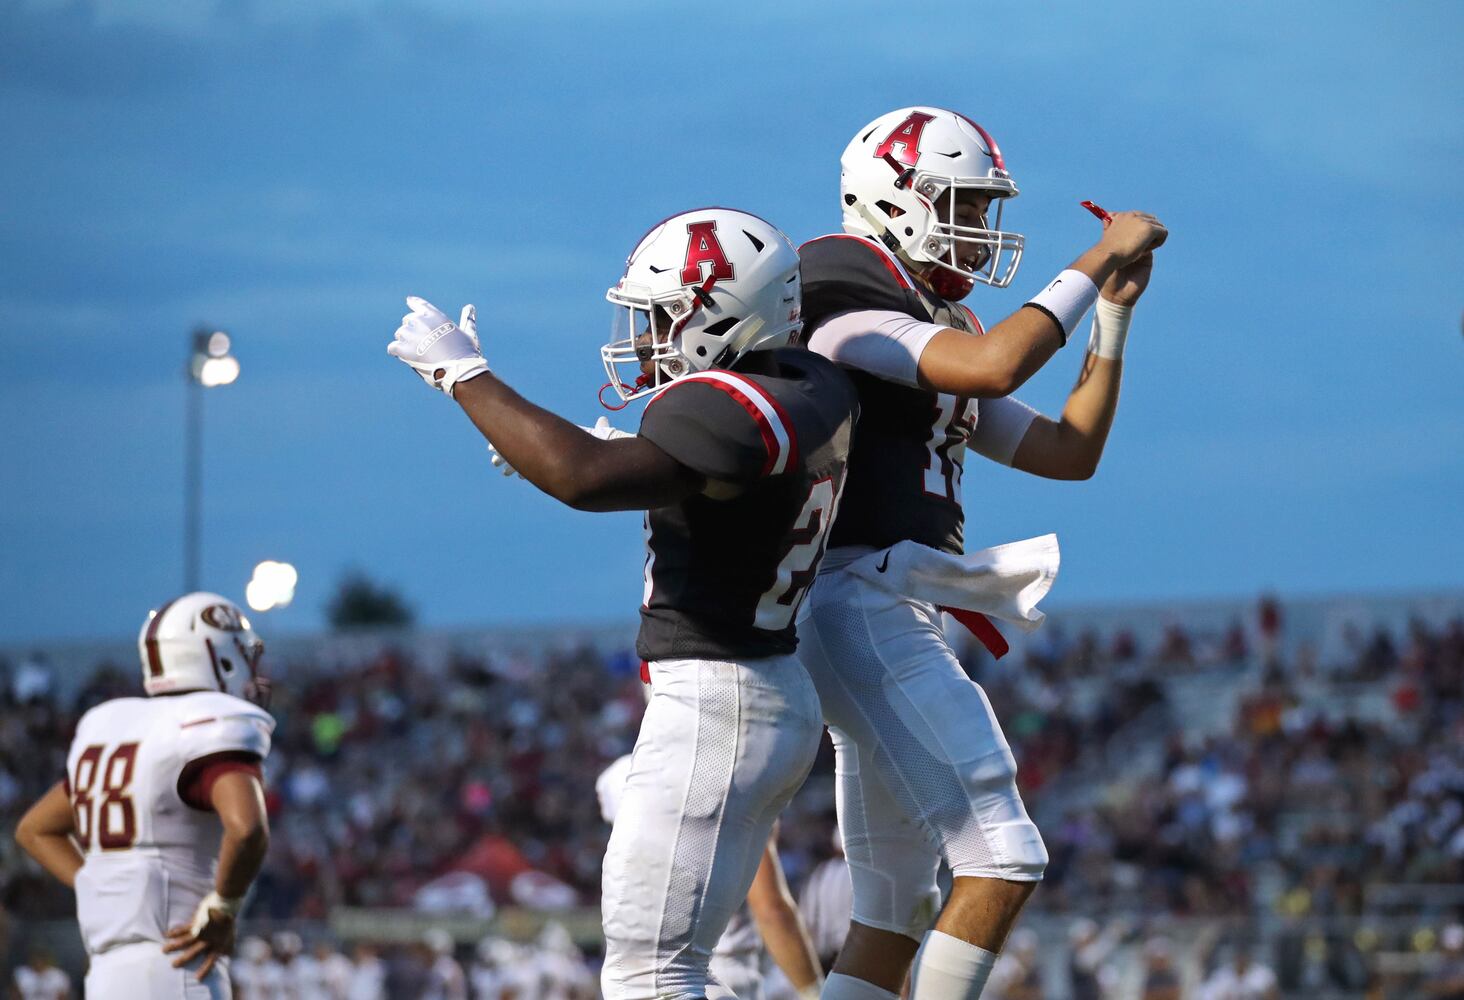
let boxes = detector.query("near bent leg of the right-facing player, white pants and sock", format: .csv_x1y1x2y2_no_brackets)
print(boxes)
799,574,1047,997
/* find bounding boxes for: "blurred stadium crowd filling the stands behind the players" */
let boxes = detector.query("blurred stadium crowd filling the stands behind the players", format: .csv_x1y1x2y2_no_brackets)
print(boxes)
0,600,1464,1000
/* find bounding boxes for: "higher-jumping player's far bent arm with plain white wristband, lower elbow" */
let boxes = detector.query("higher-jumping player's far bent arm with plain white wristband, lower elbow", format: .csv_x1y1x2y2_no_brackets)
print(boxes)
1012,253,1154,479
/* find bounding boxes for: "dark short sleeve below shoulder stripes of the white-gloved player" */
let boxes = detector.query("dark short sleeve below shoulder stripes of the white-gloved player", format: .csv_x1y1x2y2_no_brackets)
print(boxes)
640,379,779,483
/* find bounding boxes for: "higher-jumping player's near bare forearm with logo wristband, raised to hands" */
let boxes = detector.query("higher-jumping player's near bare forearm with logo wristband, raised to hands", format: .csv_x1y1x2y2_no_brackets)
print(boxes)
918,212,1168,398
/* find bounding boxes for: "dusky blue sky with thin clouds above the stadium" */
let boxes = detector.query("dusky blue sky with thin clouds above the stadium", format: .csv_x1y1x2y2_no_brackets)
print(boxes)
0,0,1464,641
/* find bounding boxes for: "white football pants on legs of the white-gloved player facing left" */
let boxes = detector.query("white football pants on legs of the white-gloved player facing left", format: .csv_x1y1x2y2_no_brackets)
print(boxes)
602,657,821,1000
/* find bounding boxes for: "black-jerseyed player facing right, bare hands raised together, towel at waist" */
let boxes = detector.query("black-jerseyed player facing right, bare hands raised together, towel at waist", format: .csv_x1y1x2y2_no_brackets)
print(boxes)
799,107,1167,1000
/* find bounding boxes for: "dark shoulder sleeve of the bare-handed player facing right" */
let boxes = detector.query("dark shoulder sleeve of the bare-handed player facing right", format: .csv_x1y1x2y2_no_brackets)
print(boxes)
798,236,930,332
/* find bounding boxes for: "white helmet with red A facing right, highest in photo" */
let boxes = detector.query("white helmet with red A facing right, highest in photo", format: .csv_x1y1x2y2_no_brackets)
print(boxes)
839,107,1025,300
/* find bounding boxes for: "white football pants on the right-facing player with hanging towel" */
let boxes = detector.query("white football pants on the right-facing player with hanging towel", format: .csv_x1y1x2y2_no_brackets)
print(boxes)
798,570,1047,940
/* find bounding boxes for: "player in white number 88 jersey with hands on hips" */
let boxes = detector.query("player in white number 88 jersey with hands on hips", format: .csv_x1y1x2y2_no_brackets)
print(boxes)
16,593,274,1000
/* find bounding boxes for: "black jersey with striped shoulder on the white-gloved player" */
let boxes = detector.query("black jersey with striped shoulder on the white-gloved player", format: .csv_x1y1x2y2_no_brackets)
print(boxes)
635,348,859,660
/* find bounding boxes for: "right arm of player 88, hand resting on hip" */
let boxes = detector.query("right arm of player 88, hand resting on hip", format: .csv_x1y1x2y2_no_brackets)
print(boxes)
163,767,269,982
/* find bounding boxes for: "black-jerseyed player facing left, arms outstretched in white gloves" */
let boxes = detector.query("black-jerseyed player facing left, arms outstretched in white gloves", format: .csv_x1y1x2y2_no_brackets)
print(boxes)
388,208,858,1000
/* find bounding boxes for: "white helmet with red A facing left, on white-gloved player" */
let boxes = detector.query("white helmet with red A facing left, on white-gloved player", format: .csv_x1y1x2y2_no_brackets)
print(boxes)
600,208,802,408
